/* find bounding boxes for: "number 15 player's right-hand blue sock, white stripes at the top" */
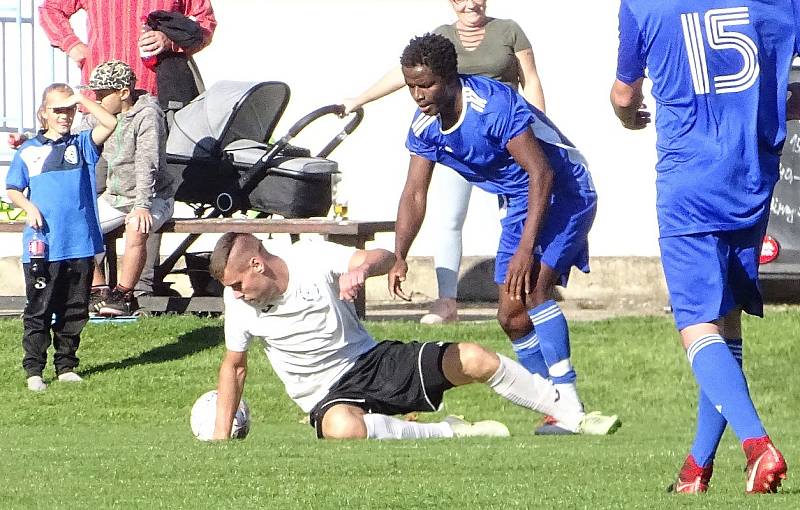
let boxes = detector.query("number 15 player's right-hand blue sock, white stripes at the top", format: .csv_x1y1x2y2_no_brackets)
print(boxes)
686,335,766,441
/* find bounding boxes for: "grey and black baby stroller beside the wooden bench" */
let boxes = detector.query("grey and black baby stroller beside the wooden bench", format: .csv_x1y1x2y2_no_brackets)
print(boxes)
154,81,364,295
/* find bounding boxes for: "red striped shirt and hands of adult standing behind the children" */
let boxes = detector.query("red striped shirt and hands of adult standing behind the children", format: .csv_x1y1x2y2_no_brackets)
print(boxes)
39,0,217,95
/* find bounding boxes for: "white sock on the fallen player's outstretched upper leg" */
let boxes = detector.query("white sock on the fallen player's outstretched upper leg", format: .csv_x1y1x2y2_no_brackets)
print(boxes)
486,354,584,431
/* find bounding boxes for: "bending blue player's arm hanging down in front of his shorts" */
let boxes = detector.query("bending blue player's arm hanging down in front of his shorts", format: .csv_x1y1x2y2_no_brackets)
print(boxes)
503,128,553,300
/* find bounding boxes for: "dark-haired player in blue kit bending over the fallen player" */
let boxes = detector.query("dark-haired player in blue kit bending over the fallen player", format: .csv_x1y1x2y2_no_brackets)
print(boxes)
389,34,619,434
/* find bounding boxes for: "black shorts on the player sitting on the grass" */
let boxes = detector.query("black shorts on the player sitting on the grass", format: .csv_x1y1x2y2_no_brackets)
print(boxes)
309,340,453,438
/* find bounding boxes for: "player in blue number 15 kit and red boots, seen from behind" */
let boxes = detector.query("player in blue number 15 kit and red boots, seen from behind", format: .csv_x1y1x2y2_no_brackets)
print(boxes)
611,0,800,493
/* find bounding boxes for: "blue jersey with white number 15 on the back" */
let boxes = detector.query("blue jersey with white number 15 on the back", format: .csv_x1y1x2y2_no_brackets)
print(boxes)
617,0,800,237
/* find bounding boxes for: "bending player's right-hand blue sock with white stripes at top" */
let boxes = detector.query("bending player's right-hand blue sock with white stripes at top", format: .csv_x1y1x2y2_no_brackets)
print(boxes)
528,300,576,384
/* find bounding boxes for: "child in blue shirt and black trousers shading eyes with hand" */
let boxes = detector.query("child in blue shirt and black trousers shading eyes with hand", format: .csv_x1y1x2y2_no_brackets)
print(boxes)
6,83,117,391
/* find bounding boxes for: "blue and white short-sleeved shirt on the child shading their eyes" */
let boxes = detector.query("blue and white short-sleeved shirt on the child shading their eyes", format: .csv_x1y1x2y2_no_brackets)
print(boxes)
6,130,104,262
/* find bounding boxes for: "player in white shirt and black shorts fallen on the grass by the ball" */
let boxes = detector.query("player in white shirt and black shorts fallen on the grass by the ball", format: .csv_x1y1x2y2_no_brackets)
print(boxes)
210,233,619,439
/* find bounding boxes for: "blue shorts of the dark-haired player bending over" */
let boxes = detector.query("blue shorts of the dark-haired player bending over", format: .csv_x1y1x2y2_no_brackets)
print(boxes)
494,192,597,287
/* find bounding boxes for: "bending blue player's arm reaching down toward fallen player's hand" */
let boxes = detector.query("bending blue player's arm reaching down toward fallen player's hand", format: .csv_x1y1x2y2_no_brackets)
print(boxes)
389,155,434,301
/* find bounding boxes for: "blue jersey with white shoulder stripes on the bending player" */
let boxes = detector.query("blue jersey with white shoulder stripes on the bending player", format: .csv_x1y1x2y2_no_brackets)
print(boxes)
406,75,594,197
